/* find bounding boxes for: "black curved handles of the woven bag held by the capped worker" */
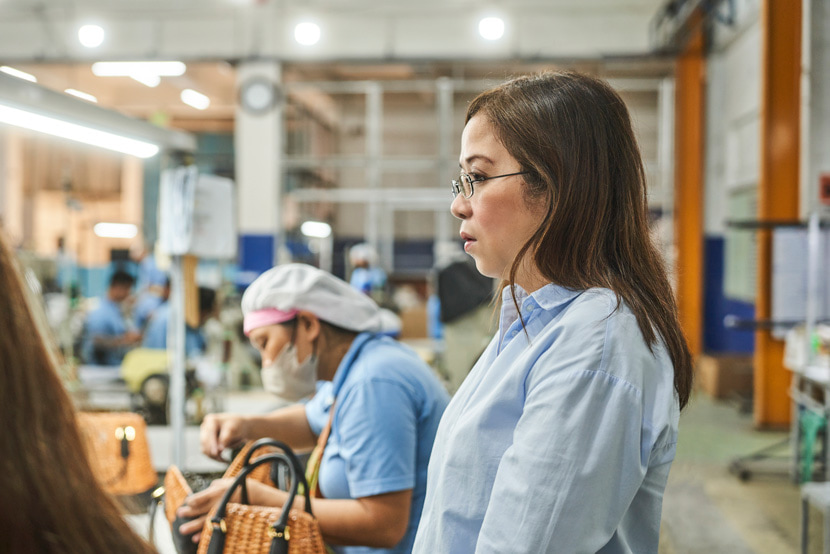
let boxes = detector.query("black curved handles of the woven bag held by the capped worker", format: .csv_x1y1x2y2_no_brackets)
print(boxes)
208,439,314,554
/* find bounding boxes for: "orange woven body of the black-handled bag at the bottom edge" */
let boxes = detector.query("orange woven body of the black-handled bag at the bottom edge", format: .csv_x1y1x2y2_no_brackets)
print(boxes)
198,502,326,554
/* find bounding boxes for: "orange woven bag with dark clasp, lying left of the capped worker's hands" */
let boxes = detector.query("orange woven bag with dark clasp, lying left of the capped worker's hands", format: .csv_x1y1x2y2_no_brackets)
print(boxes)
78,412,158,495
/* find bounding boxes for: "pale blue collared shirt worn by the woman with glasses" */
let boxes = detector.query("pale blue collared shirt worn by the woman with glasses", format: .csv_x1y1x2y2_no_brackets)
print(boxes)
413,285,679,554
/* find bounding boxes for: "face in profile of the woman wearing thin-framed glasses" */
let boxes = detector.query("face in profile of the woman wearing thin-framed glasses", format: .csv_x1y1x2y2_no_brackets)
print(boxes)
451,114,545,292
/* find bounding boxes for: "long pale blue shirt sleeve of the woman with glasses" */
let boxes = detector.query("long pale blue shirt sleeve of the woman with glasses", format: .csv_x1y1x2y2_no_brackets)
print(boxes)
476,324,653,554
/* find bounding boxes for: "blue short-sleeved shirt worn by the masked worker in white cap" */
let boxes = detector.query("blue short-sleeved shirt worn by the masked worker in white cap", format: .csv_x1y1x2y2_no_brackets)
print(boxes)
306,333,449,554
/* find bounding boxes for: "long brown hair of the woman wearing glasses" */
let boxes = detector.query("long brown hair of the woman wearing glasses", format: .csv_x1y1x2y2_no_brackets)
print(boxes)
466,72,692,408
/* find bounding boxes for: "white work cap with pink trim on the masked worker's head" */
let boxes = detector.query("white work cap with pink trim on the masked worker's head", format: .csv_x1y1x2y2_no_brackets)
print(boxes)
242,264,383,335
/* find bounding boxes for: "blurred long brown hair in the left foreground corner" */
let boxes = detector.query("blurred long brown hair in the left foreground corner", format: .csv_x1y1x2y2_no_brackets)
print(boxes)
0,231,153,553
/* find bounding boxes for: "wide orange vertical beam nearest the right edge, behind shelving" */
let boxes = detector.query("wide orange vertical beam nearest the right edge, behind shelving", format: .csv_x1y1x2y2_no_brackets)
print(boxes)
754,0,801,427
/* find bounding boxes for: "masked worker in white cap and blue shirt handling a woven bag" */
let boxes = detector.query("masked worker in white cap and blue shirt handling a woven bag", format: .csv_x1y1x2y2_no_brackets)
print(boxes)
179,264,448,554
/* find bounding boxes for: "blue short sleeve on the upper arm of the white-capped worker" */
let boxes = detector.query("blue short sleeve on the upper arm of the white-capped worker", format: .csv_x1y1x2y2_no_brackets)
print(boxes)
335,378,418,498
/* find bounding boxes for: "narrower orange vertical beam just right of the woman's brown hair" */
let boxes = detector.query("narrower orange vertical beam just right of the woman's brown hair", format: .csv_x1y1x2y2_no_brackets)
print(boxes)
674,18,706,356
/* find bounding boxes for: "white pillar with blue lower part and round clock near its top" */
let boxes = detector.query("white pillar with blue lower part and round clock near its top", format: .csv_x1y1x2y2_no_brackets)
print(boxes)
234,60,285,272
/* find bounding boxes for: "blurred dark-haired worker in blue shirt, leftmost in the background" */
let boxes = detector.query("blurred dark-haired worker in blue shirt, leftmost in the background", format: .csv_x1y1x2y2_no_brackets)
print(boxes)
81,270,141,366
